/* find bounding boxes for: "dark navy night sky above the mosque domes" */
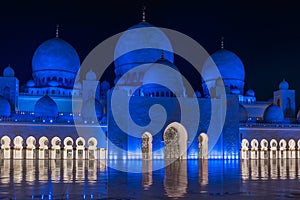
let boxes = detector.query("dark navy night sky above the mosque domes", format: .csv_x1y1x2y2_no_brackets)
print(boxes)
0,0,300,102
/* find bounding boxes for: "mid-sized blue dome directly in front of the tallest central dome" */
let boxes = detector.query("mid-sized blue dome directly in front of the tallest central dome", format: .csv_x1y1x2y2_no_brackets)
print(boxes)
143,59,185,96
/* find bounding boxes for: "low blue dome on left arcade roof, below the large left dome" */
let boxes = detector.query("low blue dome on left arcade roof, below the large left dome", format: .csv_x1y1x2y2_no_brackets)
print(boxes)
34,95,58,117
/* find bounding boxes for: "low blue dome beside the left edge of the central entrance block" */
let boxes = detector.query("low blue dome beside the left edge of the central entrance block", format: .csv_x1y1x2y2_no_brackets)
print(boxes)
81,99,103,120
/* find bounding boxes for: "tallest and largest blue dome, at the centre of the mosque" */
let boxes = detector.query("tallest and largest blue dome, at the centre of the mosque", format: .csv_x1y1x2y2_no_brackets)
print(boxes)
114,22,174,82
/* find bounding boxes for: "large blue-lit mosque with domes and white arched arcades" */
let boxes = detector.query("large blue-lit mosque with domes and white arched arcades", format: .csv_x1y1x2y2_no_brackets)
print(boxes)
0,12,300,159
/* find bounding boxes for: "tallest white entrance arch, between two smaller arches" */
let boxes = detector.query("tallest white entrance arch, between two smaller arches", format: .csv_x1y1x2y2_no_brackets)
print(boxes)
163,122,188,159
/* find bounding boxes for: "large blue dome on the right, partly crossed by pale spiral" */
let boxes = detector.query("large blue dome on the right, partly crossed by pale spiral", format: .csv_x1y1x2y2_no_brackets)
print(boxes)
201,48,245,96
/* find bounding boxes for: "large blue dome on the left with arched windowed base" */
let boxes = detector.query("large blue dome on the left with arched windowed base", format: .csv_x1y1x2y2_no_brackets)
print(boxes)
32,38,80,87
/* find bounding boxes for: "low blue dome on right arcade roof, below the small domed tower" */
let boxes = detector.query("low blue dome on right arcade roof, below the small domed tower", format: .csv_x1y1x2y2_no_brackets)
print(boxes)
263,104,284,123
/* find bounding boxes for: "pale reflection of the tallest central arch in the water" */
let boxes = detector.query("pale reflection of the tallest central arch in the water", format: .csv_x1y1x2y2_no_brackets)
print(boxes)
164,160,188,197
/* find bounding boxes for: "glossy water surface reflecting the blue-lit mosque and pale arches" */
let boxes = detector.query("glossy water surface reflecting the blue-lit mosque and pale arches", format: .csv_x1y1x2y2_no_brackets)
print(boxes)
0,159,300,199
